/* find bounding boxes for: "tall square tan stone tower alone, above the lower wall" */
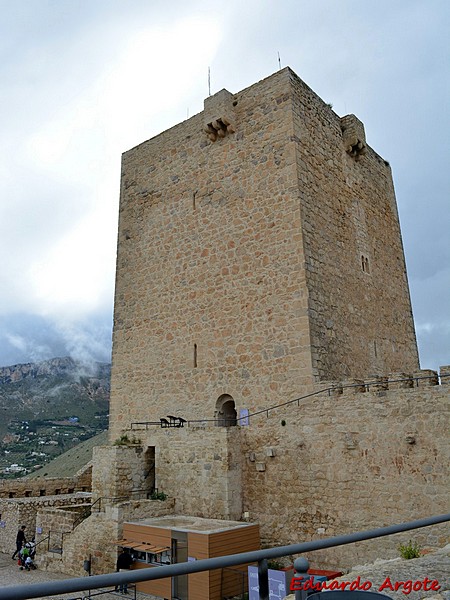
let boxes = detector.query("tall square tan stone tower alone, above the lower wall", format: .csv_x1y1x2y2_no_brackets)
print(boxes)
110,68,418,439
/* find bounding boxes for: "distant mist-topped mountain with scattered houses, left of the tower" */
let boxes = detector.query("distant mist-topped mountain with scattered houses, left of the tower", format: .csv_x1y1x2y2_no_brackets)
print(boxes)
0,357,111,478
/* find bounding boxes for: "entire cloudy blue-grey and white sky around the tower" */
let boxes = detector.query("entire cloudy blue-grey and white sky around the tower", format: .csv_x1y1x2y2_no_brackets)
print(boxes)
0,0,450,368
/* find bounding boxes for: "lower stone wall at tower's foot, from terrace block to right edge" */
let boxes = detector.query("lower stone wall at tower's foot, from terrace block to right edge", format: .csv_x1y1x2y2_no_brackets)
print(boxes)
107,367,450,568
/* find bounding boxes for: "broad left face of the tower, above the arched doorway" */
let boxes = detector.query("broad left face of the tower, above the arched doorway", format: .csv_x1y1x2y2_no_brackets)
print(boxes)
110,70,312,440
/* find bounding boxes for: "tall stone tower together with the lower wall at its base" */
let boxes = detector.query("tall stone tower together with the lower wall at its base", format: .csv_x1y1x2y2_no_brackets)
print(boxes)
96,69,450,567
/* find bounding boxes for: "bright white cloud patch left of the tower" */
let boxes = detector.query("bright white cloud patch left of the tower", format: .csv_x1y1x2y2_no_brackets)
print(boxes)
0,11,220,317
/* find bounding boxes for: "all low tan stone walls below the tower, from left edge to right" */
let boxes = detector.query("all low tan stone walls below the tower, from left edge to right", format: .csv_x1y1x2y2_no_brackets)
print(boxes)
0,367,450,576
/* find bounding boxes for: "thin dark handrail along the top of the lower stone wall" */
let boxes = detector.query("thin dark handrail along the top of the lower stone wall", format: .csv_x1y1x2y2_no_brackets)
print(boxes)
131,374,450,430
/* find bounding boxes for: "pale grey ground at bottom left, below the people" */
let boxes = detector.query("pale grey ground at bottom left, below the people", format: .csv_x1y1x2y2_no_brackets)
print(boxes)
0,553,161,600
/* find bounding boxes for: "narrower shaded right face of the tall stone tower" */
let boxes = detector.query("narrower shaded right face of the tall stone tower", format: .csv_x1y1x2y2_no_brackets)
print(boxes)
291,73,419,380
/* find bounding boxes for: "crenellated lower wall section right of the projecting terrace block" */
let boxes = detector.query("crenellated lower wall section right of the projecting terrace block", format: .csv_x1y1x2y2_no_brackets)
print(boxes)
241,372,450,567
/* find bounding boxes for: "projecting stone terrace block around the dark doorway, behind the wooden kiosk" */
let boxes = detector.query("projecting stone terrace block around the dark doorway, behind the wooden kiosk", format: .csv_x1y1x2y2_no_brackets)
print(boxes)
93,424,242,519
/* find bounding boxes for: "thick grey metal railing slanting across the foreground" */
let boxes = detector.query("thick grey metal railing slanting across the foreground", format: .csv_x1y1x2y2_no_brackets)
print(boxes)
0,513,450,600
